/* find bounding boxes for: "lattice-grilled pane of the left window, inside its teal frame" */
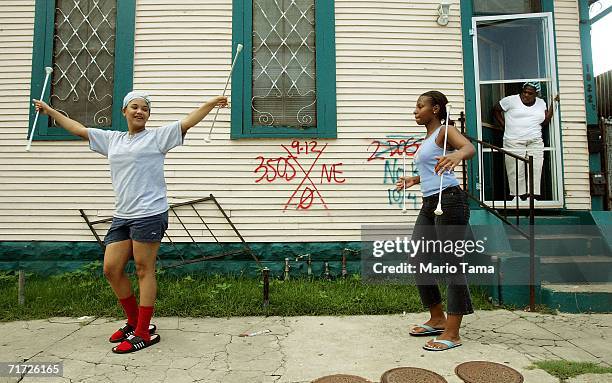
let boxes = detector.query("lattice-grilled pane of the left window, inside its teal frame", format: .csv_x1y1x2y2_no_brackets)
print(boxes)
51,0,117,127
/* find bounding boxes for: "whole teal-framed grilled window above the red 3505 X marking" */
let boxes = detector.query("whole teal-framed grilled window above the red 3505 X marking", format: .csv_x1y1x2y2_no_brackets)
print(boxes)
232,0,336,138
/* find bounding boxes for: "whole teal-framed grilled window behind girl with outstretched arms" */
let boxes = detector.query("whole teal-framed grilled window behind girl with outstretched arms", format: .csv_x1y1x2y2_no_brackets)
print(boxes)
30,0,135,140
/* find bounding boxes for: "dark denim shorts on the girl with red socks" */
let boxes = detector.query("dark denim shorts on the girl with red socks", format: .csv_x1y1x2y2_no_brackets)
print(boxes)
104,212,168,245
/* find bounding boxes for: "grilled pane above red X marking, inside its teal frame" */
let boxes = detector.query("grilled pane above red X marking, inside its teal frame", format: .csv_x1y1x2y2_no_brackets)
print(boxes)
251,0,317,129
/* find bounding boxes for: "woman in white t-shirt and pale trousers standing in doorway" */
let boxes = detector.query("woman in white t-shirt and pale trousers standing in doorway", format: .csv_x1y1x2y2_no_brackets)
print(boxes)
493,82,559,200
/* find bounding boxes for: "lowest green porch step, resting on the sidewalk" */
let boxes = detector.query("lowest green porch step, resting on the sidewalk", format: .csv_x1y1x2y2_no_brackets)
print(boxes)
541,283,612,313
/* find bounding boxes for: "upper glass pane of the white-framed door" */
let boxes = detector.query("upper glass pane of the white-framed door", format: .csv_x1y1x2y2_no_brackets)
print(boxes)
477,18,548,81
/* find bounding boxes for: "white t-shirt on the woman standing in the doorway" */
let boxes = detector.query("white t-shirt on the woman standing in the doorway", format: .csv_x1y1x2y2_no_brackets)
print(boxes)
499,94,546,140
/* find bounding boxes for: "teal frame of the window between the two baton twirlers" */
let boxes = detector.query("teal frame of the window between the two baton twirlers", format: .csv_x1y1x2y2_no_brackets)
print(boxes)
231,0,337,140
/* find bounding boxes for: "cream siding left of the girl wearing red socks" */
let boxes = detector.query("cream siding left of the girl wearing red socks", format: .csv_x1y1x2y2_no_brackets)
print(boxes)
0,0,118,241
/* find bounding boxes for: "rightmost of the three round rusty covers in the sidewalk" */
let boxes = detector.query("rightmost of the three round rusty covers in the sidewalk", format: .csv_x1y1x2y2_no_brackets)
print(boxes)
455,361,523,383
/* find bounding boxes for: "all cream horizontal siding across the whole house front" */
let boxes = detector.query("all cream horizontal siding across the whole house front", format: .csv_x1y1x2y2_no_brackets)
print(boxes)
0,0,589,242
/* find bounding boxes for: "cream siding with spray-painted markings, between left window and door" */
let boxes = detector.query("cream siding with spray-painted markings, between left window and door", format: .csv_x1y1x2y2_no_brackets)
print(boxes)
128,1,463,241
